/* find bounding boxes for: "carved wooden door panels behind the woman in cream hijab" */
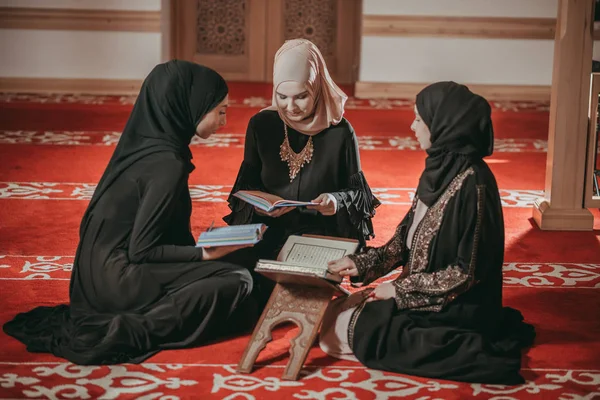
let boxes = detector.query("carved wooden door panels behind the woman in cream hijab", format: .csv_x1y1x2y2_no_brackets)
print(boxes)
170,0,361,83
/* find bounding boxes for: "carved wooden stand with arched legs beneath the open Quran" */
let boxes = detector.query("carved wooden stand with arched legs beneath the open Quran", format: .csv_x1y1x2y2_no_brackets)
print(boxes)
237,235,350,381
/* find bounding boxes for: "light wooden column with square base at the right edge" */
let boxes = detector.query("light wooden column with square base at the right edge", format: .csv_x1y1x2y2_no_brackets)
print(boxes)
533,0,594,230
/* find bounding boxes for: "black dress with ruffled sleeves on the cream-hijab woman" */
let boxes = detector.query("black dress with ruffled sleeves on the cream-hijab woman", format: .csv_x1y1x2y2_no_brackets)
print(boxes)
224,111,380,258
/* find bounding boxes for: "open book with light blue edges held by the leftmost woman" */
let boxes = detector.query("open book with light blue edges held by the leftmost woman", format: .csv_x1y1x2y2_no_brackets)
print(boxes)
196,224,267,247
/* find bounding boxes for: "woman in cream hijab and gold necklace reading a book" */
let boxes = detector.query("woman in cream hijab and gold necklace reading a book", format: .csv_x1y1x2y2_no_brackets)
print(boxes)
224,39,379,306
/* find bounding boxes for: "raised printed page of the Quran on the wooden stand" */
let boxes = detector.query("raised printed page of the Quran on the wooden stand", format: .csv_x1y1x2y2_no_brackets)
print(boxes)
278,235,358,269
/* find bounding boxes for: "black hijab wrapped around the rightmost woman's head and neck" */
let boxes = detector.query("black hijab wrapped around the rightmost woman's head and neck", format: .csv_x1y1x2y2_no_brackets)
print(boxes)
416,82,494,207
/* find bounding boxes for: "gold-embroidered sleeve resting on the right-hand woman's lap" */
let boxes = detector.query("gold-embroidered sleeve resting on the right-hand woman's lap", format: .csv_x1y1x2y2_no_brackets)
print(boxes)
394,186,485,311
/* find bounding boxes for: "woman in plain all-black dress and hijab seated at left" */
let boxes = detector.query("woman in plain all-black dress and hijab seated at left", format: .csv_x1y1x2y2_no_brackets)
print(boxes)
4,60,252,365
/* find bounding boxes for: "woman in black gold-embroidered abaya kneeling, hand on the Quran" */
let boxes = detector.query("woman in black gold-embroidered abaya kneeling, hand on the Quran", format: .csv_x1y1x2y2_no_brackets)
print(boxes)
320,82,535,384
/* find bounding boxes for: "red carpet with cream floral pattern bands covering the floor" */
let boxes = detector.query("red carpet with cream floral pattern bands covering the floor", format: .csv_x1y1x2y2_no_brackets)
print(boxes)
0,84,600,400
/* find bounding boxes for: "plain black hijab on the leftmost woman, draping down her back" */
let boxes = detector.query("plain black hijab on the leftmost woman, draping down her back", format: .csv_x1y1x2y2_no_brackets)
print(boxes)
79,60,228,235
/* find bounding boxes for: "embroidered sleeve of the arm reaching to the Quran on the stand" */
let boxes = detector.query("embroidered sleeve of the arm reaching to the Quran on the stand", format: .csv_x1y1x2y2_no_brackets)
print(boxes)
348,219,412,285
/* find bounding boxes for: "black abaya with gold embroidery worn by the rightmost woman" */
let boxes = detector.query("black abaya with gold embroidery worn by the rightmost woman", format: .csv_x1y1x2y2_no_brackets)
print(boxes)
348,162,534,384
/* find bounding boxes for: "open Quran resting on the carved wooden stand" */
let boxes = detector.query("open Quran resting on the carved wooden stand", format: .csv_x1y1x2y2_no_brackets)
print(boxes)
255,235,358,293
